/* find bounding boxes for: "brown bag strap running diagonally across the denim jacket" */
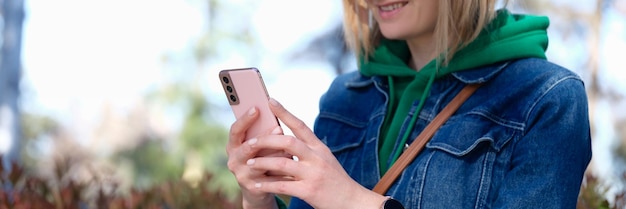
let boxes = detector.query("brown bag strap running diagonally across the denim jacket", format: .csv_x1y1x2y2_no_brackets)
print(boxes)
372,84,480,195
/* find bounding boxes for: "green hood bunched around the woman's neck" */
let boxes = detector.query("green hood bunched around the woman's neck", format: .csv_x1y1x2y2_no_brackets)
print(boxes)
359,10,549,77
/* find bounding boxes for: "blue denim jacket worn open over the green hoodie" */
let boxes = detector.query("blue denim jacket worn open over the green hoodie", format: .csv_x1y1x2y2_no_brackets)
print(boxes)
290,58,591,209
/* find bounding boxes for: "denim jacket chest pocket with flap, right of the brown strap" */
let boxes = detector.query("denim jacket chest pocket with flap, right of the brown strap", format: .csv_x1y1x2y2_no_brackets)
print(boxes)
399,115,515,208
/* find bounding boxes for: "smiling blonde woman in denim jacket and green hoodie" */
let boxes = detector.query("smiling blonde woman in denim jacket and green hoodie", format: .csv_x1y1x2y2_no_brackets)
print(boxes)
227,0,591,209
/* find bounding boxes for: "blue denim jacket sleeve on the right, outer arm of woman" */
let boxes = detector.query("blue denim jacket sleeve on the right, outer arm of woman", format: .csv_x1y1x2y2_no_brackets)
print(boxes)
493,77,591,209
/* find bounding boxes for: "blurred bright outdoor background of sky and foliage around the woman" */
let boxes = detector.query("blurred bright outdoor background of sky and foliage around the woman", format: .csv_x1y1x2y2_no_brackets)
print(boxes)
0,0,626,208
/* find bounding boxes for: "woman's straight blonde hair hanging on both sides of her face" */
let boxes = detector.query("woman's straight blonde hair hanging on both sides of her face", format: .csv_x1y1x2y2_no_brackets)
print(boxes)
343,0,507,66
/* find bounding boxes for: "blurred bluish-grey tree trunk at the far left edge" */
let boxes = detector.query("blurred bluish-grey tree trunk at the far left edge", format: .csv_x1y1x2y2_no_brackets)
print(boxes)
0,0,24,165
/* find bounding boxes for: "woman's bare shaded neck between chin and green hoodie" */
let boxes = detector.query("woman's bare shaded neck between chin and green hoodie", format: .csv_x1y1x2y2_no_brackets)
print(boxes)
407,37,436,71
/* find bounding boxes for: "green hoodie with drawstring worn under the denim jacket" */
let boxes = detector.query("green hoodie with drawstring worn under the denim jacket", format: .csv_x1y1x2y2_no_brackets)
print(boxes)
359,10,549,175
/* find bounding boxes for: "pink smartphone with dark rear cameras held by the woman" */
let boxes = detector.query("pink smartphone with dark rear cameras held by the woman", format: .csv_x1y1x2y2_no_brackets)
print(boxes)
219,68,279,138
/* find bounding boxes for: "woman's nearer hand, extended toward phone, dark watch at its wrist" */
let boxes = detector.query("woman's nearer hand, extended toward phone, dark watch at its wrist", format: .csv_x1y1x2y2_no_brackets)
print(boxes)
241,99,385,209
